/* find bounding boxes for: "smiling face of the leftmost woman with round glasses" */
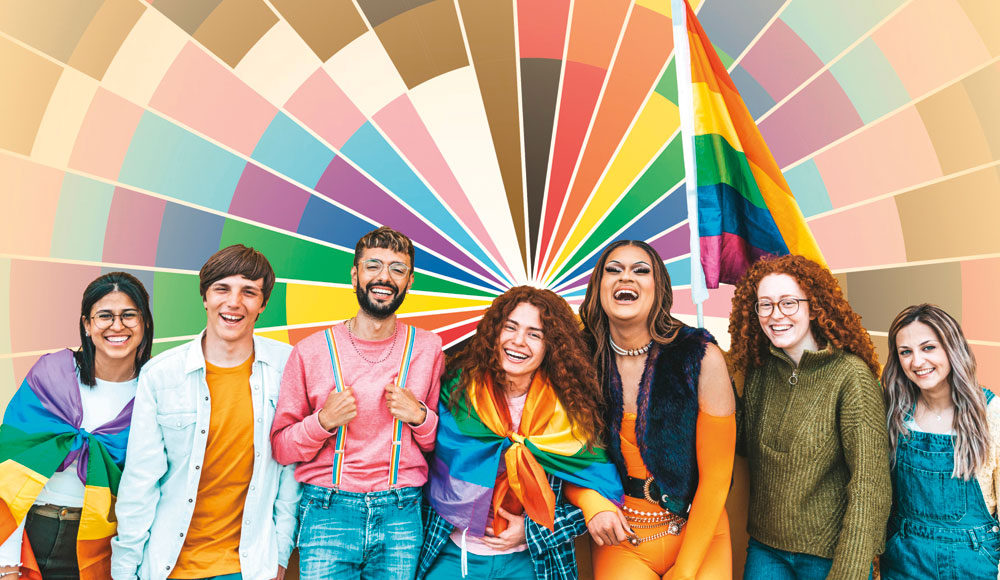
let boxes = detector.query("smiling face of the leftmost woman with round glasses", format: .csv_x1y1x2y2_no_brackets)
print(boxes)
83,291,144,375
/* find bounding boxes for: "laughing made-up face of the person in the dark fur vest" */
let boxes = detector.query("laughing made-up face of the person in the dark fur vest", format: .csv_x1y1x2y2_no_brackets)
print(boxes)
600,245,656,324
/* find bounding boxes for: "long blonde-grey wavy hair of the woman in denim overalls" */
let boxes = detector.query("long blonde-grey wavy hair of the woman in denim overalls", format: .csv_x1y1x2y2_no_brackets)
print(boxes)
882,304,989,480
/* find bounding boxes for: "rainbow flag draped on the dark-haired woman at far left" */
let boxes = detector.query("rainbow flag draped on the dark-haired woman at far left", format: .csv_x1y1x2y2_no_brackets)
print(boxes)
0,350,132,580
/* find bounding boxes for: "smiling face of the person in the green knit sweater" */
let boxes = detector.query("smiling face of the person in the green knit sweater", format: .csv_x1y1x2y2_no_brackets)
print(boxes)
751,274,817,362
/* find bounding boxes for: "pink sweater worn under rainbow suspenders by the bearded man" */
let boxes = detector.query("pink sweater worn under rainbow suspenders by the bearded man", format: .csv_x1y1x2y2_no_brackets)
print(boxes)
271,321,444,492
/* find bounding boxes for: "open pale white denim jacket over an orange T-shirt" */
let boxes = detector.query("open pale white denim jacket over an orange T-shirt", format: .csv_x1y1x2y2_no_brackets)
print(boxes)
111,332,299,580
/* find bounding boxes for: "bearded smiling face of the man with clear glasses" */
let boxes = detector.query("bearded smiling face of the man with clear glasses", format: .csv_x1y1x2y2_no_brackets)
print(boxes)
351,248,413,318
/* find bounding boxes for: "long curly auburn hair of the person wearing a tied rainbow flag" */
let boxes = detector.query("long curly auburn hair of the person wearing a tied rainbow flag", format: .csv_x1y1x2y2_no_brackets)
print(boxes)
446,286,604,447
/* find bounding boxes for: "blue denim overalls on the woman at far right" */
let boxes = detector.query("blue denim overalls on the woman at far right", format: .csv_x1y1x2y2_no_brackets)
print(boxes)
880,392,1000,580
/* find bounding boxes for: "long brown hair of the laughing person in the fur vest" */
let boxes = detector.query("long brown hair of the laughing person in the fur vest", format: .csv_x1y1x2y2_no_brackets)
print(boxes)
580,240,684,377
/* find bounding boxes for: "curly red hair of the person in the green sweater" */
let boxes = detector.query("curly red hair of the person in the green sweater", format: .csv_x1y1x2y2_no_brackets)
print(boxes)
729,254,881,377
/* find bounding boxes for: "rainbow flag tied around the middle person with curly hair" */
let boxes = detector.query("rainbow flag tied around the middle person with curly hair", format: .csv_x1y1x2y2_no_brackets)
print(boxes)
428,373,624,536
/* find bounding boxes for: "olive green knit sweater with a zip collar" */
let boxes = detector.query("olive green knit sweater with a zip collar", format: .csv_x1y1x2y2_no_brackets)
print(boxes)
738,347,892,580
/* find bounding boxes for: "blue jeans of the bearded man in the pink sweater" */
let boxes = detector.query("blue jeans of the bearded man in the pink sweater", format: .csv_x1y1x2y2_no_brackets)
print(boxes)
296,484,424,580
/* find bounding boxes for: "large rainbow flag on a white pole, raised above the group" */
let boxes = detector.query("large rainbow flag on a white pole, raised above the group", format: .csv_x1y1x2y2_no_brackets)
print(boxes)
671,0,826,303
